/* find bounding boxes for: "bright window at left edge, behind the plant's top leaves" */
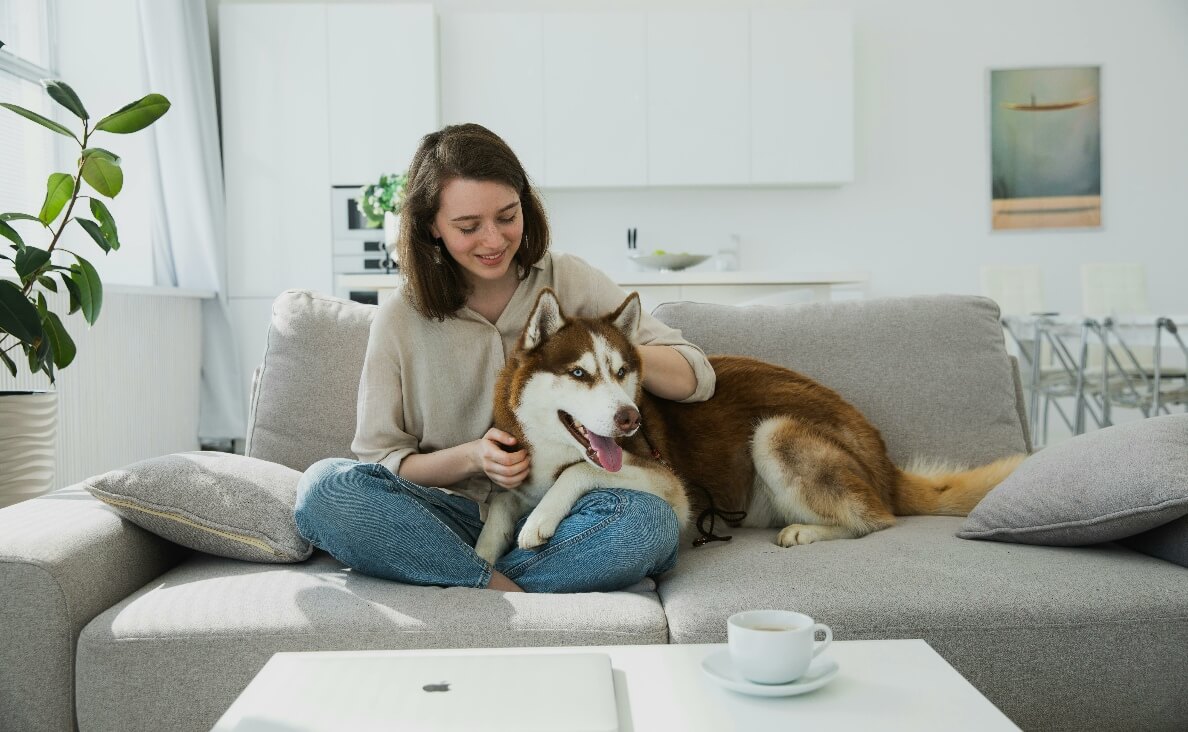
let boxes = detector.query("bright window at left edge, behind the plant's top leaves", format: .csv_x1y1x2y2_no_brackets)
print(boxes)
0,0,58,234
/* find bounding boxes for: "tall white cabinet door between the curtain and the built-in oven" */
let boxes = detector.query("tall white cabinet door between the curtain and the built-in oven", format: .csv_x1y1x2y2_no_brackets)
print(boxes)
219,4,333,297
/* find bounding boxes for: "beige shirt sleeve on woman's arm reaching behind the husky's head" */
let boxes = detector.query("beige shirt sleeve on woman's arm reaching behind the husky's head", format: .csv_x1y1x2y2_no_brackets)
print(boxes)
554,254,718,403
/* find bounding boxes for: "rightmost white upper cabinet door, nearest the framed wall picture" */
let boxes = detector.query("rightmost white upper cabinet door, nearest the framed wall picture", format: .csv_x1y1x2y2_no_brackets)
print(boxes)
751,10,854,184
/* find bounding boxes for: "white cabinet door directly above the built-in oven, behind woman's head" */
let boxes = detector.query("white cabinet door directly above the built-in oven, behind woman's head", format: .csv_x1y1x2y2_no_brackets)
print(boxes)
326,2,440,185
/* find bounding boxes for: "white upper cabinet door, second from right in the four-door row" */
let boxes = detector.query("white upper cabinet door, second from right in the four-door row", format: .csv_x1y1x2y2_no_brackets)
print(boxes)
647,11,751,185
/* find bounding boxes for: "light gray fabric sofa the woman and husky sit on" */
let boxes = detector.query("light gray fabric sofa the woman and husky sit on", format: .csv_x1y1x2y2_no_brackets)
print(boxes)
0,291,1188,732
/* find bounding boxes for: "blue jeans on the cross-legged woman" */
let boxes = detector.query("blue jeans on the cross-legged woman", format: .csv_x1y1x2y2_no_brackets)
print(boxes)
295,458,678,592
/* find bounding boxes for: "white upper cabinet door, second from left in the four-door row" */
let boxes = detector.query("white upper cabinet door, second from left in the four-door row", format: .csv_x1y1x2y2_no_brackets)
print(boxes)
542,12,647,188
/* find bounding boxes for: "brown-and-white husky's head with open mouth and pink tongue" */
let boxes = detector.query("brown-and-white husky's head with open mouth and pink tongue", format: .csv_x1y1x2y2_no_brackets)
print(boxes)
499,289,643,472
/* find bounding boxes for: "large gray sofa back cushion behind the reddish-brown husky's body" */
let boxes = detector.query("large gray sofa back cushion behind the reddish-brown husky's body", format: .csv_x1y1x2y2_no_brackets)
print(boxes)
653,296,1029,465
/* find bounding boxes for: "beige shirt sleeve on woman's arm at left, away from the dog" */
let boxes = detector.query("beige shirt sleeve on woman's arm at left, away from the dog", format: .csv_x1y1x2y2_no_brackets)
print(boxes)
350,298,417,473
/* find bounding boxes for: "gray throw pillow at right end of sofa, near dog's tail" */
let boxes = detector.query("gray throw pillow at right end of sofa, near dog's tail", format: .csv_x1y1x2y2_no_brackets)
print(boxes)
958,414,1188,547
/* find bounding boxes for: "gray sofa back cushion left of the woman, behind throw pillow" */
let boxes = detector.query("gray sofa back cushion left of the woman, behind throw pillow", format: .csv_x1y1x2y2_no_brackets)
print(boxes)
245,290,377,471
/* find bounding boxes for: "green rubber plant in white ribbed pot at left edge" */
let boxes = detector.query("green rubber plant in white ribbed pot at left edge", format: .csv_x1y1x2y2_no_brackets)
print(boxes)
0,60,170,507
